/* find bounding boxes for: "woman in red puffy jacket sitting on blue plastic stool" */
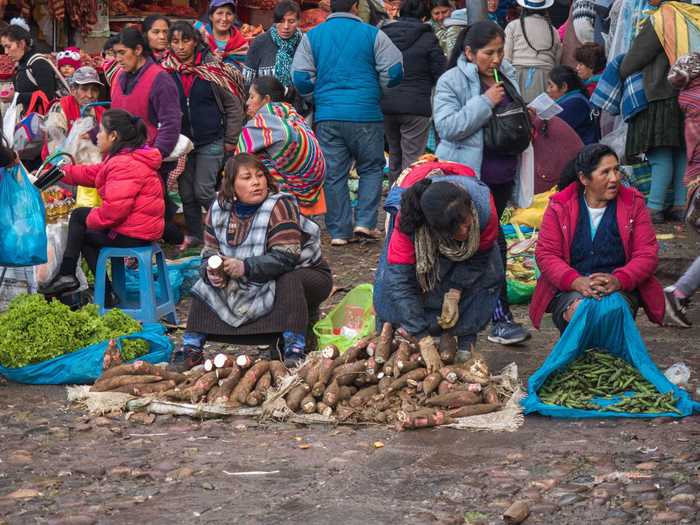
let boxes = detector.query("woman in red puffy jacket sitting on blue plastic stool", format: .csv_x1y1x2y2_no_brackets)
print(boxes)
39,109,165,295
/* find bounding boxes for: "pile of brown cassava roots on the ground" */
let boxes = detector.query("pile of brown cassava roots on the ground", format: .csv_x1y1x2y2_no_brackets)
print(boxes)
93,323,504,430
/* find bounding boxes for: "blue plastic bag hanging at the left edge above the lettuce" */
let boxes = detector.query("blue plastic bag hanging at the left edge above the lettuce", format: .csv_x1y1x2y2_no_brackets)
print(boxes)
0,165,47,266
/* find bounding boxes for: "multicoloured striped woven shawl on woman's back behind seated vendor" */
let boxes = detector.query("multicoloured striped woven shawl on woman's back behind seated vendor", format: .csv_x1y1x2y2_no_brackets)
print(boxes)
238,102,326,213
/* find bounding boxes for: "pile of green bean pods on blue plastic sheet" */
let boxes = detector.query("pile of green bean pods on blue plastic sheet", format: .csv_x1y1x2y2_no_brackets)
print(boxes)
539,349,680,414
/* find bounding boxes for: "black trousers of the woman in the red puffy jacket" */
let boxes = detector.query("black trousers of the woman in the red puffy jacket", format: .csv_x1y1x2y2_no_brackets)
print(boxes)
59,208,151,275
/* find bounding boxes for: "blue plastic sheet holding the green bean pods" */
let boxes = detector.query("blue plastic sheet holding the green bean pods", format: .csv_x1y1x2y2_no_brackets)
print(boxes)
521,293,700,418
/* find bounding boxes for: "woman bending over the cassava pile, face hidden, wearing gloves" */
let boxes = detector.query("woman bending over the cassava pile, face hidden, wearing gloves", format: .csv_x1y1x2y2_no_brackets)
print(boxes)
374,162,503,364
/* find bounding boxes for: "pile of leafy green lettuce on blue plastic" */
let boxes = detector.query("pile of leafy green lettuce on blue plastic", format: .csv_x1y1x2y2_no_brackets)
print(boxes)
0,294,149,368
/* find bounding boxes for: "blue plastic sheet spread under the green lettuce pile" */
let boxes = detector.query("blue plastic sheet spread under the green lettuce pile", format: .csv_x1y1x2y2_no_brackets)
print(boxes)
0,323,173,385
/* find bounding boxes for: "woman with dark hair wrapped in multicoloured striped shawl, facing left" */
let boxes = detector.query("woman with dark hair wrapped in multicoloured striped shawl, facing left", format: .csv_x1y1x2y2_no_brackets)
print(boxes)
238,77,326,216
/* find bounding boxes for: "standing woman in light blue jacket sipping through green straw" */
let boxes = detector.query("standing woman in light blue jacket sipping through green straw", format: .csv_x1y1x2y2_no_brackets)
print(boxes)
433,20,534,344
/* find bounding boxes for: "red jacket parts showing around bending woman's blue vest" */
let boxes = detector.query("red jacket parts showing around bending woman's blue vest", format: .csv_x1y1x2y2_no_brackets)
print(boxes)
387,162,499,264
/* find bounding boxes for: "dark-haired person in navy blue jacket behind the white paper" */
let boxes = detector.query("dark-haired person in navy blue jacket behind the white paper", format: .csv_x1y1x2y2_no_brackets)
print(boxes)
547,66,600,146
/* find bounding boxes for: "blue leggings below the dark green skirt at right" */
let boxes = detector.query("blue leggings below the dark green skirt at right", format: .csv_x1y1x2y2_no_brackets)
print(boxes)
647,147,687,211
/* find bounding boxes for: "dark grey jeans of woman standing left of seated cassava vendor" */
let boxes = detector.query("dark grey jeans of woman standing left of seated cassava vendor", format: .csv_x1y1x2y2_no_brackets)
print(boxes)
178,139,224,241
